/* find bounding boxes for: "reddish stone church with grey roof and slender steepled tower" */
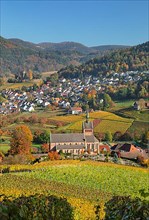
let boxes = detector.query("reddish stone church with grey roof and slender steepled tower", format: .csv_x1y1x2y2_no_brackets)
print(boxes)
50,113,99,155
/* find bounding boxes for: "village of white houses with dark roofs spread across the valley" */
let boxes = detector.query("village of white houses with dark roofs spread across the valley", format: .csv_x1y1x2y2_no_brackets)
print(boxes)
0,71,149,114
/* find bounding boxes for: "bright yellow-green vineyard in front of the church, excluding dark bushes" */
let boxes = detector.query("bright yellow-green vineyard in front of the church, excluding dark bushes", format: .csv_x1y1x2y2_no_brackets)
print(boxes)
0,160,148,220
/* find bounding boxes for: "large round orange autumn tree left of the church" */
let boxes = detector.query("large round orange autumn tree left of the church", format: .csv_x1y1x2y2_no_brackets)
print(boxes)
10,125,33,155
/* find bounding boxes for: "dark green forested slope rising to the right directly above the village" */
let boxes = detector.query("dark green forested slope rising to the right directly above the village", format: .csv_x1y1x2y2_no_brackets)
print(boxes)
59,41,149,78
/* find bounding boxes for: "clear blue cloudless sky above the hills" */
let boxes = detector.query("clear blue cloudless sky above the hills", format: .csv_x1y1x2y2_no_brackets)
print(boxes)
0,0,149,46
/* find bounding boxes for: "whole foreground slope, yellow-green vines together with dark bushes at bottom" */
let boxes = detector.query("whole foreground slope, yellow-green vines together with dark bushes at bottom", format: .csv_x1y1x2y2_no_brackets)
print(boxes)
0,160,148,220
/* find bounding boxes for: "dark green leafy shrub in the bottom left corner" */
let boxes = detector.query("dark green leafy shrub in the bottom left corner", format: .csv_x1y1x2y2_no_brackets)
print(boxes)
0,194,74,220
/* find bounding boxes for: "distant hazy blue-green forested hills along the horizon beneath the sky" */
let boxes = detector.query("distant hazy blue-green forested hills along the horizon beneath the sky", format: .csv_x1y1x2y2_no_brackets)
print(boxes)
0,37,127,76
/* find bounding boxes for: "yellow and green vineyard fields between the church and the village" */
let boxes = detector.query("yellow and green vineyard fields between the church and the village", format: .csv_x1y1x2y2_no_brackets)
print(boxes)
0,111,133,153
